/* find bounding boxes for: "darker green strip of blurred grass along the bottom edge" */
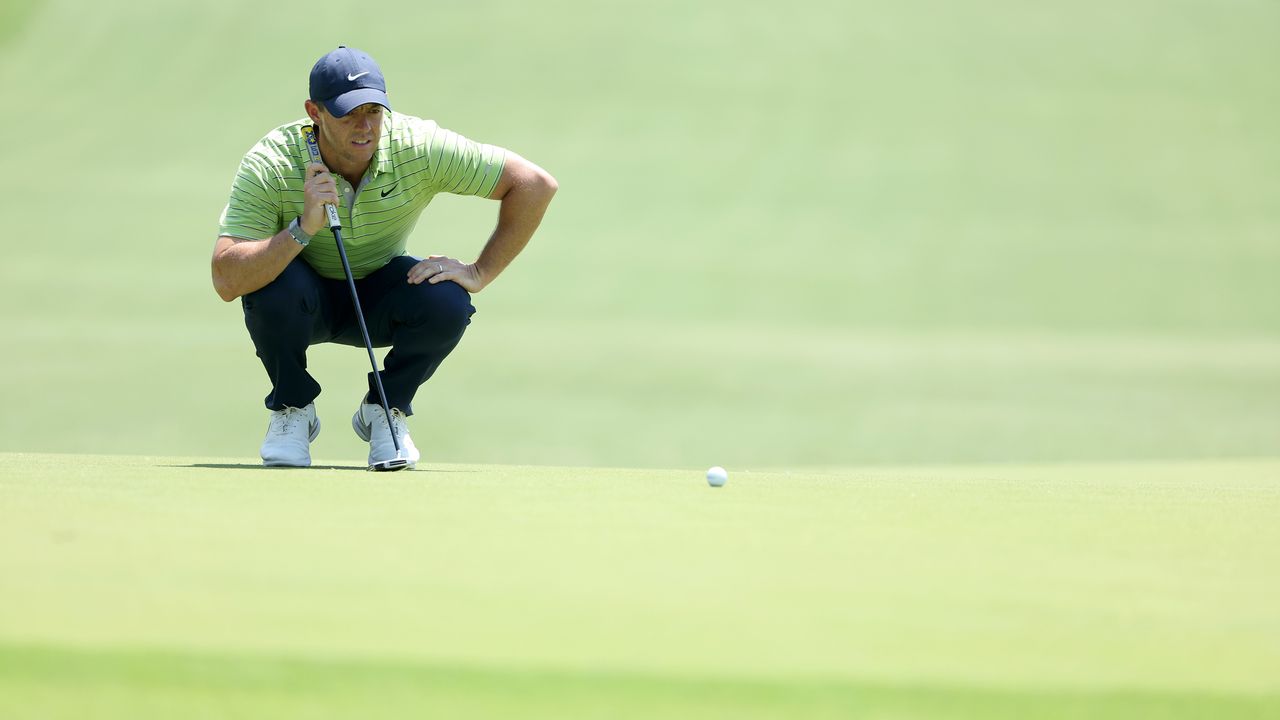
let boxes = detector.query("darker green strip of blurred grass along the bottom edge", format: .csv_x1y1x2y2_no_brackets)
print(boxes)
0,643,1280,720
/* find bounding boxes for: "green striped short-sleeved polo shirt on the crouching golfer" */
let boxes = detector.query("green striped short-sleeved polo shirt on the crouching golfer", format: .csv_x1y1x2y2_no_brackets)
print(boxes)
218,110,507,279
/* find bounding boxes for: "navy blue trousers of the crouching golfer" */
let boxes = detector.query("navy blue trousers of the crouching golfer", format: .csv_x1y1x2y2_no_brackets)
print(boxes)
241,255,475,415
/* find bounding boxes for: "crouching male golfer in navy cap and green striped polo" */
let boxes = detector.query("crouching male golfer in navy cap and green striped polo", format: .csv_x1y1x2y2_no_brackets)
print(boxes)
212,46,557,466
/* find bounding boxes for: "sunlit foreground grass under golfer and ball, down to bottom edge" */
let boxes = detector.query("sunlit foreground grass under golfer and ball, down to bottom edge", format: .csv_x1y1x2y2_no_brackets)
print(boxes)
0,455,1280,717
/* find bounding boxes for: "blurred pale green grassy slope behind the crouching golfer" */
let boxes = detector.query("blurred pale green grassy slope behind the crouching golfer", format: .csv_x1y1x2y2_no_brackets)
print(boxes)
0,0,1280,468
